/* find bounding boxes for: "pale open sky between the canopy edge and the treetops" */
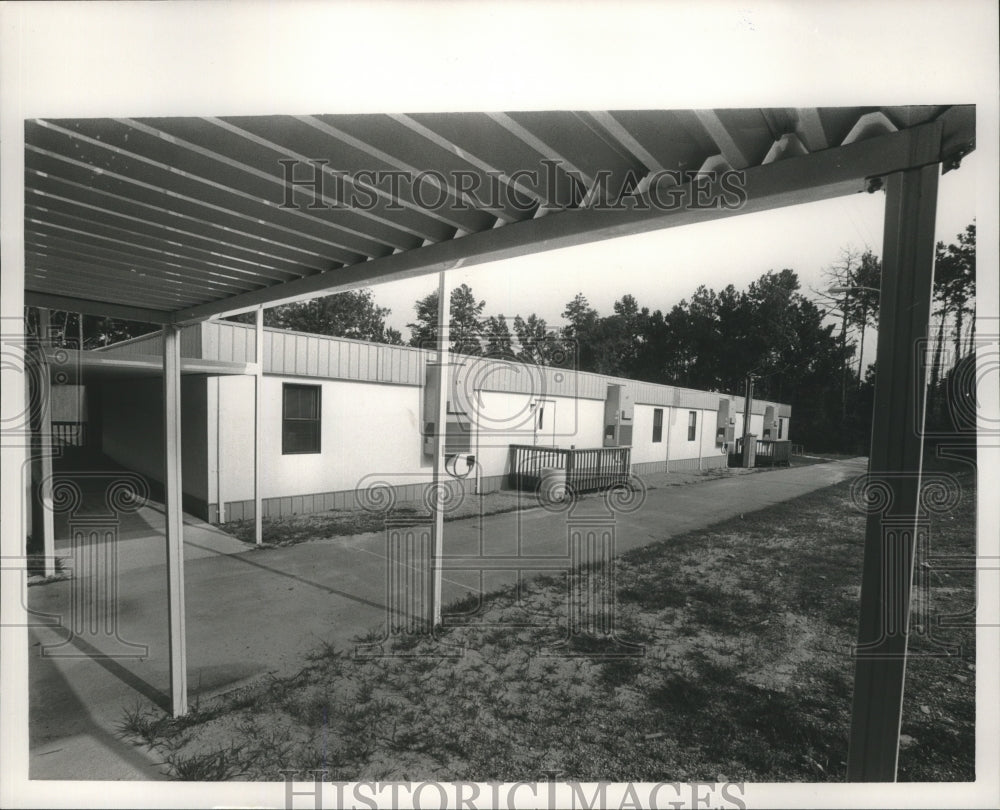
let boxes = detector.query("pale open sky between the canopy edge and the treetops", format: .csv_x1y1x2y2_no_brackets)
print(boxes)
373,152,977,363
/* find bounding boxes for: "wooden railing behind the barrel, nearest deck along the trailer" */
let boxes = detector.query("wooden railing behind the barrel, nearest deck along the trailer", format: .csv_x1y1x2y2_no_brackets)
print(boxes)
510,444,632,493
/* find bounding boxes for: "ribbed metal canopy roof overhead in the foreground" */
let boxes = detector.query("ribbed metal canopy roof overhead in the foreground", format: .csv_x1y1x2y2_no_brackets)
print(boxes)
25,106,975,323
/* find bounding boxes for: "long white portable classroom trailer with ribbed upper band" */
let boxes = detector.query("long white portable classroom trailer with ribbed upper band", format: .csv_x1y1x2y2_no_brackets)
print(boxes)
90,320,791,522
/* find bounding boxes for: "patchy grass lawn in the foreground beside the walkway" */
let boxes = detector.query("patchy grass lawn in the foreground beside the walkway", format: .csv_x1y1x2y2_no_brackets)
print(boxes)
123,464,975,782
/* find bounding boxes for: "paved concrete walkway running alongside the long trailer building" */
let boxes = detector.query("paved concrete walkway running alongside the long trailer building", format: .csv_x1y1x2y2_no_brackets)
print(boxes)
28,459,866,779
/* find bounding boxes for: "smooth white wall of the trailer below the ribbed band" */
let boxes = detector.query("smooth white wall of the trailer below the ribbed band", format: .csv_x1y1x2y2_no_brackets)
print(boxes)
207,375,787,519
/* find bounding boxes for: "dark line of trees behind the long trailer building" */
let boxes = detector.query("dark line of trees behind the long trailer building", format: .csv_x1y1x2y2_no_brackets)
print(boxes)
29,218,976,453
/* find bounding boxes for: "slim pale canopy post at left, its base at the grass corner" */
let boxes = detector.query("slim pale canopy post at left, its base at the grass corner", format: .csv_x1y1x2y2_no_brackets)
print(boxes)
163,326,187,717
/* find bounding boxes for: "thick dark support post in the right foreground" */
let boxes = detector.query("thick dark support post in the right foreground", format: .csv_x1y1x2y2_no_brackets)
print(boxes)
847,165,939,782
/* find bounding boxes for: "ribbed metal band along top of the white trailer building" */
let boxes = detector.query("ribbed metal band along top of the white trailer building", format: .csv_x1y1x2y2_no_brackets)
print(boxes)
195,321,792,418
